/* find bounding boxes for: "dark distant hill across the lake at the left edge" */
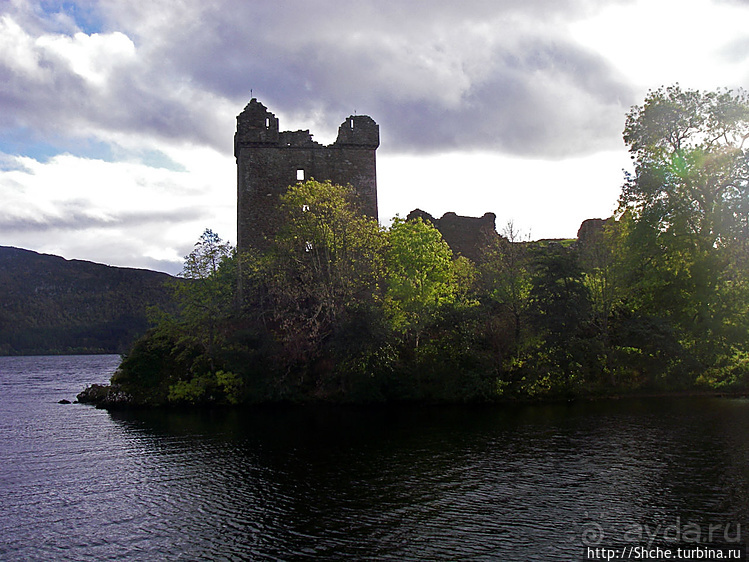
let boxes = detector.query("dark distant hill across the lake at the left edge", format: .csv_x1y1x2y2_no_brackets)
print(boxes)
0,246,173,355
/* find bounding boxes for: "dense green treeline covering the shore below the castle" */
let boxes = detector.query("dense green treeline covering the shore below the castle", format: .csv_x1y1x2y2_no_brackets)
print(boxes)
105,86,749,404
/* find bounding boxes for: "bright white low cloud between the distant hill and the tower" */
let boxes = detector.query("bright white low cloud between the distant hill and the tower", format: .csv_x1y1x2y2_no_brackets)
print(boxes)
0,149,236,273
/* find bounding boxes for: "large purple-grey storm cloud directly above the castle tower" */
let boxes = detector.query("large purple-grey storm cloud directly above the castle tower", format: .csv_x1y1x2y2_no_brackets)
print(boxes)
103,0,634,156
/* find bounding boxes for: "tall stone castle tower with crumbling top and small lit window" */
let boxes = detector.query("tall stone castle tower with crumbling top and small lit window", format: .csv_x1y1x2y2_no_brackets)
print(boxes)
234,98,380,250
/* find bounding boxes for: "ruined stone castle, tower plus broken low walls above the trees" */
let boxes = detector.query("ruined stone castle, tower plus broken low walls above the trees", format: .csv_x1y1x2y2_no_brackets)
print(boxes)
234,98,613,261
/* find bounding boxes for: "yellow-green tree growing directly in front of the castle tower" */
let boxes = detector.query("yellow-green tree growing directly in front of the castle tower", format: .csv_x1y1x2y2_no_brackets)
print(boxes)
241,180,383,386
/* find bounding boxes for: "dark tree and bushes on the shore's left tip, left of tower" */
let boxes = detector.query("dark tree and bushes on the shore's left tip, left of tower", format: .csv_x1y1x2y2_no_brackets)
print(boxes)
112,229,241,405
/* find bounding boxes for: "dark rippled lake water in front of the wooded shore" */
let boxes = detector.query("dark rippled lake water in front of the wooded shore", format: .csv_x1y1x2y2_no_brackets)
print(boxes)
0,356,749,561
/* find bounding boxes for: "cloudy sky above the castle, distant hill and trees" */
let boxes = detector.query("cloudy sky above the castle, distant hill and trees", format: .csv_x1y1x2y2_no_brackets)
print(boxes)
0,0,749,274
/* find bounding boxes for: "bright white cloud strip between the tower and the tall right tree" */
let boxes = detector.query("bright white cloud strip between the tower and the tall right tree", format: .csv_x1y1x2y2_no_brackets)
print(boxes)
377,151,630,239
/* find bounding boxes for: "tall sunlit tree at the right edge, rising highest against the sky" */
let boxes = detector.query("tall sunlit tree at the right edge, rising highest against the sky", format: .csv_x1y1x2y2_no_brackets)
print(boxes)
619,85,749,380
